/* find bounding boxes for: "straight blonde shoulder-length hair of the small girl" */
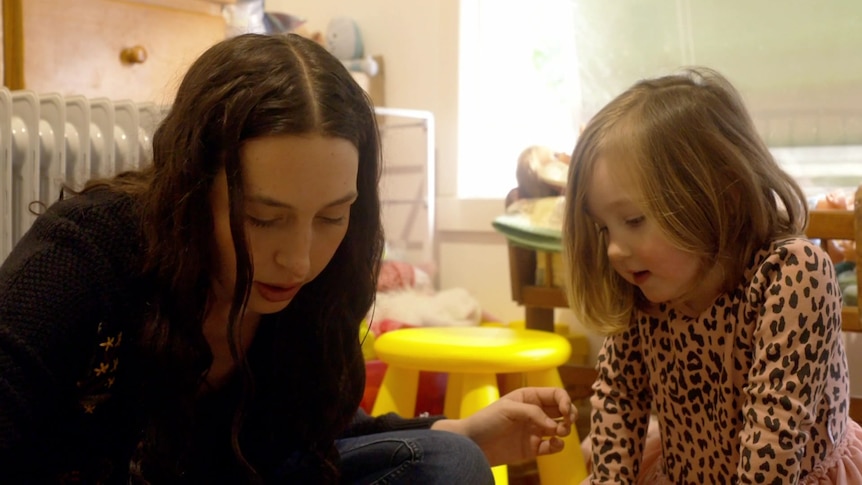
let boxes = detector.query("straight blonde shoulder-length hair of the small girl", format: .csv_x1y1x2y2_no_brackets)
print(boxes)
563,68,808,334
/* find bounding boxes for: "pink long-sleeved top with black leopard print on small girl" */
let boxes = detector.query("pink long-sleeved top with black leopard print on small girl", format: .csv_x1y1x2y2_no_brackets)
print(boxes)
591,238,849,484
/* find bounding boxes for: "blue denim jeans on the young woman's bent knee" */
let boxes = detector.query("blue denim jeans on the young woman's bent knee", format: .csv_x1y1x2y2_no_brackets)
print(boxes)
336,429,494,485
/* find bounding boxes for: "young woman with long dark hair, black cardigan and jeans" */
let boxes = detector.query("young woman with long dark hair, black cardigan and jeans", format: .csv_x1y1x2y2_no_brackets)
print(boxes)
0,35,573,483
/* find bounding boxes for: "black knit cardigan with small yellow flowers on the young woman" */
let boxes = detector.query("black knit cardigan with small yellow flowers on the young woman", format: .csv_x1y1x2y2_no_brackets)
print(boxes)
0,190,442,483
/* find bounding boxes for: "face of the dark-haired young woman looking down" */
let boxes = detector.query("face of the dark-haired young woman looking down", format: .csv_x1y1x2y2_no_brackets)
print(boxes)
210,135,359,315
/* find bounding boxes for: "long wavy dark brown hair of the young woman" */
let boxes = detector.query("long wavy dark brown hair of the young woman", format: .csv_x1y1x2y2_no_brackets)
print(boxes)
77,34,383,481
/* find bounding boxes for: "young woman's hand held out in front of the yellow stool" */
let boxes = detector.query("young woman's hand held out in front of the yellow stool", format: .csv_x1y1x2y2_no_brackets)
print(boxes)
431,387,577,466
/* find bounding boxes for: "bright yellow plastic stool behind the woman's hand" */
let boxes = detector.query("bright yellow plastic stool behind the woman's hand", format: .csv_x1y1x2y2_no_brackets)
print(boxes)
371,327,587,485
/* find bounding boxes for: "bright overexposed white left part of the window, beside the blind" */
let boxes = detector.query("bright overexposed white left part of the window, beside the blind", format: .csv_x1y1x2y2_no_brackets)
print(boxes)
458,0,582,198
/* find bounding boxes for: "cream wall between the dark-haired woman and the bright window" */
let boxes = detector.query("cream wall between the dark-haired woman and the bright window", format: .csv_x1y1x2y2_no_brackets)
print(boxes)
266,0,536,328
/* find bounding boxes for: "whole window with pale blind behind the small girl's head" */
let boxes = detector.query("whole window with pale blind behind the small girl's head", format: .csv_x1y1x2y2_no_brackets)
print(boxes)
458,0,862,198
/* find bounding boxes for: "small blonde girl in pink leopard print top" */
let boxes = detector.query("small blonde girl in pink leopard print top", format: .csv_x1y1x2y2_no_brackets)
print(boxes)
564,69,862,484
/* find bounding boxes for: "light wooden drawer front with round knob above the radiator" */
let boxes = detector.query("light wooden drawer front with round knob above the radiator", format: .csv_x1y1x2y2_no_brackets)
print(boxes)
10,0,225,104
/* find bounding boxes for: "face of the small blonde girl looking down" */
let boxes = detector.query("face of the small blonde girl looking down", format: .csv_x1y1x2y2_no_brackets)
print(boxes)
587,159,718,315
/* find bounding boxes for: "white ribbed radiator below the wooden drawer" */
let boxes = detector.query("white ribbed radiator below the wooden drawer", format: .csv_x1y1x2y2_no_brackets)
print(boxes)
0,87,164,261
